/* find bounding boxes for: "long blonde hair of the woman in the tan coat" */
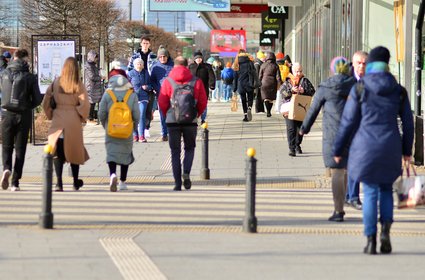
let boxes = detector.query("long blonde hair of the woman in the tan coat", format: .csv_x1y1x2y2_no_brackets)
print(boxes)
59,57,80,93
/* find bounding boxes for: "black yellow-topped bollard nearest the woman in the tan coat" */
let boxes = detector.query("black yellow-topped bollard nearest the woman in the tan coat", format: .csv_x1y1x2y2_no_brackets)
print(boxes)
38,148,53,229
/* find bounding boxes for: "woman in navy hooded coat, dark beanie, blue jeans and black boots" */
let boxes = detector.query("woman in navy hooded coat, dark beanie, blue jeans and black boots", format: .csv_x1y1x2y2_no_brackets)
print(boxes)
332,46,414,255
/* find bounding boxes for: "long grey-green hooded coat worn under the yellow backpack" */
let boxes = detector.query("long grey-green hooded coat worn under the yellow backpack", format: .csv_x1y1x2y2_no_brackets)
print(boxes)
98,75,140,165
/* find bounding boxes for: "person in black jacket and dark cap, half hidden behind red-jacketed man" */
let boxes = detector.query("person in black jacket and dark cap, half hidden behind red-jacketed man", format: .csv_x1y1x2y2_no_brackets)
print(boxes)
189,51,215,124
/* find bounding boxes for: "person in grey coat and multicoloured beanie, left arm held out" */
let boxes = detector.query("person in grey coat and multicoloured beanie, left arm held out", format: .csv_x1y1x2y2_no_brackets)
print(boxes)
300,56,356,222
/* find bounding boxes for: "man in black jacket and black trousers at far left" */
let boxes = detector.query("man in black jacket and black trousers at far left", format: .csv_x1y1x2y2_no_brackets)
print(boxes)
0,49,43,191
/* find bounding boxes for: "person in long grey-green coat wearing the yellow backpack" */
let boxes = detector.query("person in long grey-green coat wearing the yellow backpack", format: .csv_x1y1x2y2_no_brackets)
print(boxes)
99,67,143,192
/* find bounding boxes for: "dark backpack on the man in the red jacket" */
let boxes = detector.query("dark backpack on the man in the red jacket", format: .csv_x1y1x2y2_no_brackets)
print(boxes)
167,77,198,124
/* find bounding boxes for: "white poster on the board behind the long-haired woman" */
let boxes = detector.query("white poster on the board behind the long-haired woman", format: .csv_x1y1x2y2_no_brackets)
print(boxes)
37,40,75,93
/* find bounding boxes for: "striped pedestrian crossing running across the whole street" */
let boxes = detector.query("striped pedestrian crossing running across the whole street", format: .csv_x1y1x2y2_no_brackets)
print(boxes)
0,184,425,236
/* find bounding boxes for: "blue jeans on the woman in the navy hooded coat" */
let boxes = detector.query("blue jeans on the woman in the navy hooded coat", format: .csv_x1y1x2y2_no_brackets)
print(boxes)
362,182,394,236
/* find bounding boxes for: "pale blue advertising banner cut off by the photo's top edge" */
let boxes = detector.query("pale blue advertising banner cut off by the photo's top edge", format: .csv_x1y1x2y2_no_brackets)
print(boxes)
149,0,230,12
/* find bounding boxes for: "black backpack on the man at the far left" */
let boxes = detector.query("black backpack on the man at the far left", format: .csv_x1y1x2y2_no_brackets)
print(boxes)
1,69,31,112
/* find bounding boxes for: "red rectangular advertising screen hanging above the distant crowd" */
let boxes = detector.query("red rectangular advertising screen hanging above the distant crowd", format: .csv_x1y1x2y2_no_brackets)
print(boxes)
211,30,246,52
